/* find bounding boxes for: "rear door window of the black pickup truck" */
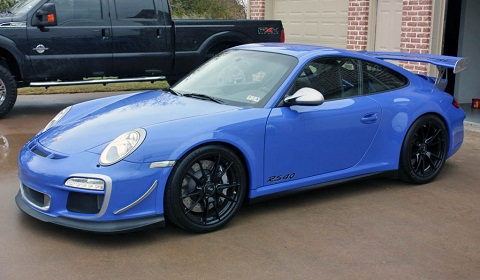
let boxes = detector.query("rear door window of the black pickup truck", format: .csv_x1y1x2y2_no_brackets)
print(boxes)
115,0,157,20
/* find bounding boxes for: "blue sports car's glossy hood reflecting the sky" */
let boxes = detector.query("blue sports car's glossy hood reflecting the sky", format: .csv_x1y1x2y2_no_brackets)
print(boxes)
38,91,239,155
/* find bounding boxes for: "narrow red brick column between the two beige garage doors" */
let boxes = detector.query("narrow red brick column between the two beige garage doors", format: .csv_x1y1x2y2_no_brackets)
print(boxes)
347,0,370,50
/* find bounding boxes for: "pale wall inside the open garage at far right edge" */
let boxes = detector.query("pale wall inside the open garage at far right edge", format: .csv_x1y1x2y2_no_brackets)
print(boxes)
456,0,480,103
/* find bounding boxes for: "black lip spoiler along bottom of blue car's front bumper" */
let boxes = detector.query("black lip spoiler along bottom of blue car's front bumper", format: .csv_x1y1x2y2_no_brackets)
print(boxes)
15,191,165,233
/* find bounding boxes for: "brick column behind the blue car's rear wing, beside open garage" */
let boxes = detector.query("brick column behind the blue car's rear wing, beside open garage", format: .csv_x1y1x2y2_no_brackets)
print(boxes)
400,0,432,74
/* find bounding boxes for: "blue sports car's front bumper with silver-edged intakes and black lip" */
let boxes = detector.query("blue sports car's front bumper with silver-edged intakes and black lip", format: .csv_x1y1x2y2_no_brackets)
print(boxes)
15,141,171,233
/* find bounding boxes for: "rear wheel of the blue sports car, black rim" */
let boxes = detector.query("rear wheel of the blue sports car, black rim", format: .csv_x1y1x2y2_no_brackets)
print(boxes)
399,115,448,184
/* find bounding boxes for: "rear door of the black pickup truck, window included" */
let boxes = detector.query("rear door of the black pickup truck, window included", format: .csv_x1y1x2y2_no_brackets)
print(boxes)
110,0,173,77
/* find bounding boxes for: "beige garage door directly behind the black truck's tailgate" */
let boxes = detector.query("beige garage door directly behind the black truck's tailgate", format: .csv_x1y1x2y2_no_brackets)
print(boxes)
273,0,348,49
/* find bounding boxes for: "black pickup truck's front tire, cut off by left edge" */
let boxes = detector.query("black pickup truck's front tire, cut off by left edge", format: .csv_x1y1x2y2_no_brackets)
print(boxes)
0,65,17,118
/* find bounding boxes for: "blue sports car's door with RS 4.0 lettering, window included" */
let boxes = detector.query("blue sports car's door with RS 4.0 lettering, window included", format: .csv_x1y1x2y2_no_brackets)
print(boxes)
264,57,382,185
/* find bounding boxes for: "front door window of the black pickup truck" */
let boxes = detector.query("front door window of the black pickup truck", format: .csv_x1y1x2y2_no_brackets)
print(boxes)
50,0,102,25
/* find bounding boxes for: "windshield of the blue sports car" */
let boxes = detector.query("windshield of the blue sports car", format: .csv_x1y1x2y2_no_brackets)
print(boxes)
173,50,297,108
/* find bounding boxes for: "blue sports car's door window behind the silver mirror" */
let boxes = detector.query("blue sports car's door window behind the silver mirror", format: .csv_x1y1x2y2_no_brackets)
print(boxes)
292,57,362,100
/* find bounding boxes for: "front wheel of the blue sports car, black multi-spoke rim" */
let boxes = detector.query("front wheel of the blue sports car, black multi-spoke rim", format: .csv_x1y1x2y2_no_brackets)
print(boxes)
164,145,247,233
